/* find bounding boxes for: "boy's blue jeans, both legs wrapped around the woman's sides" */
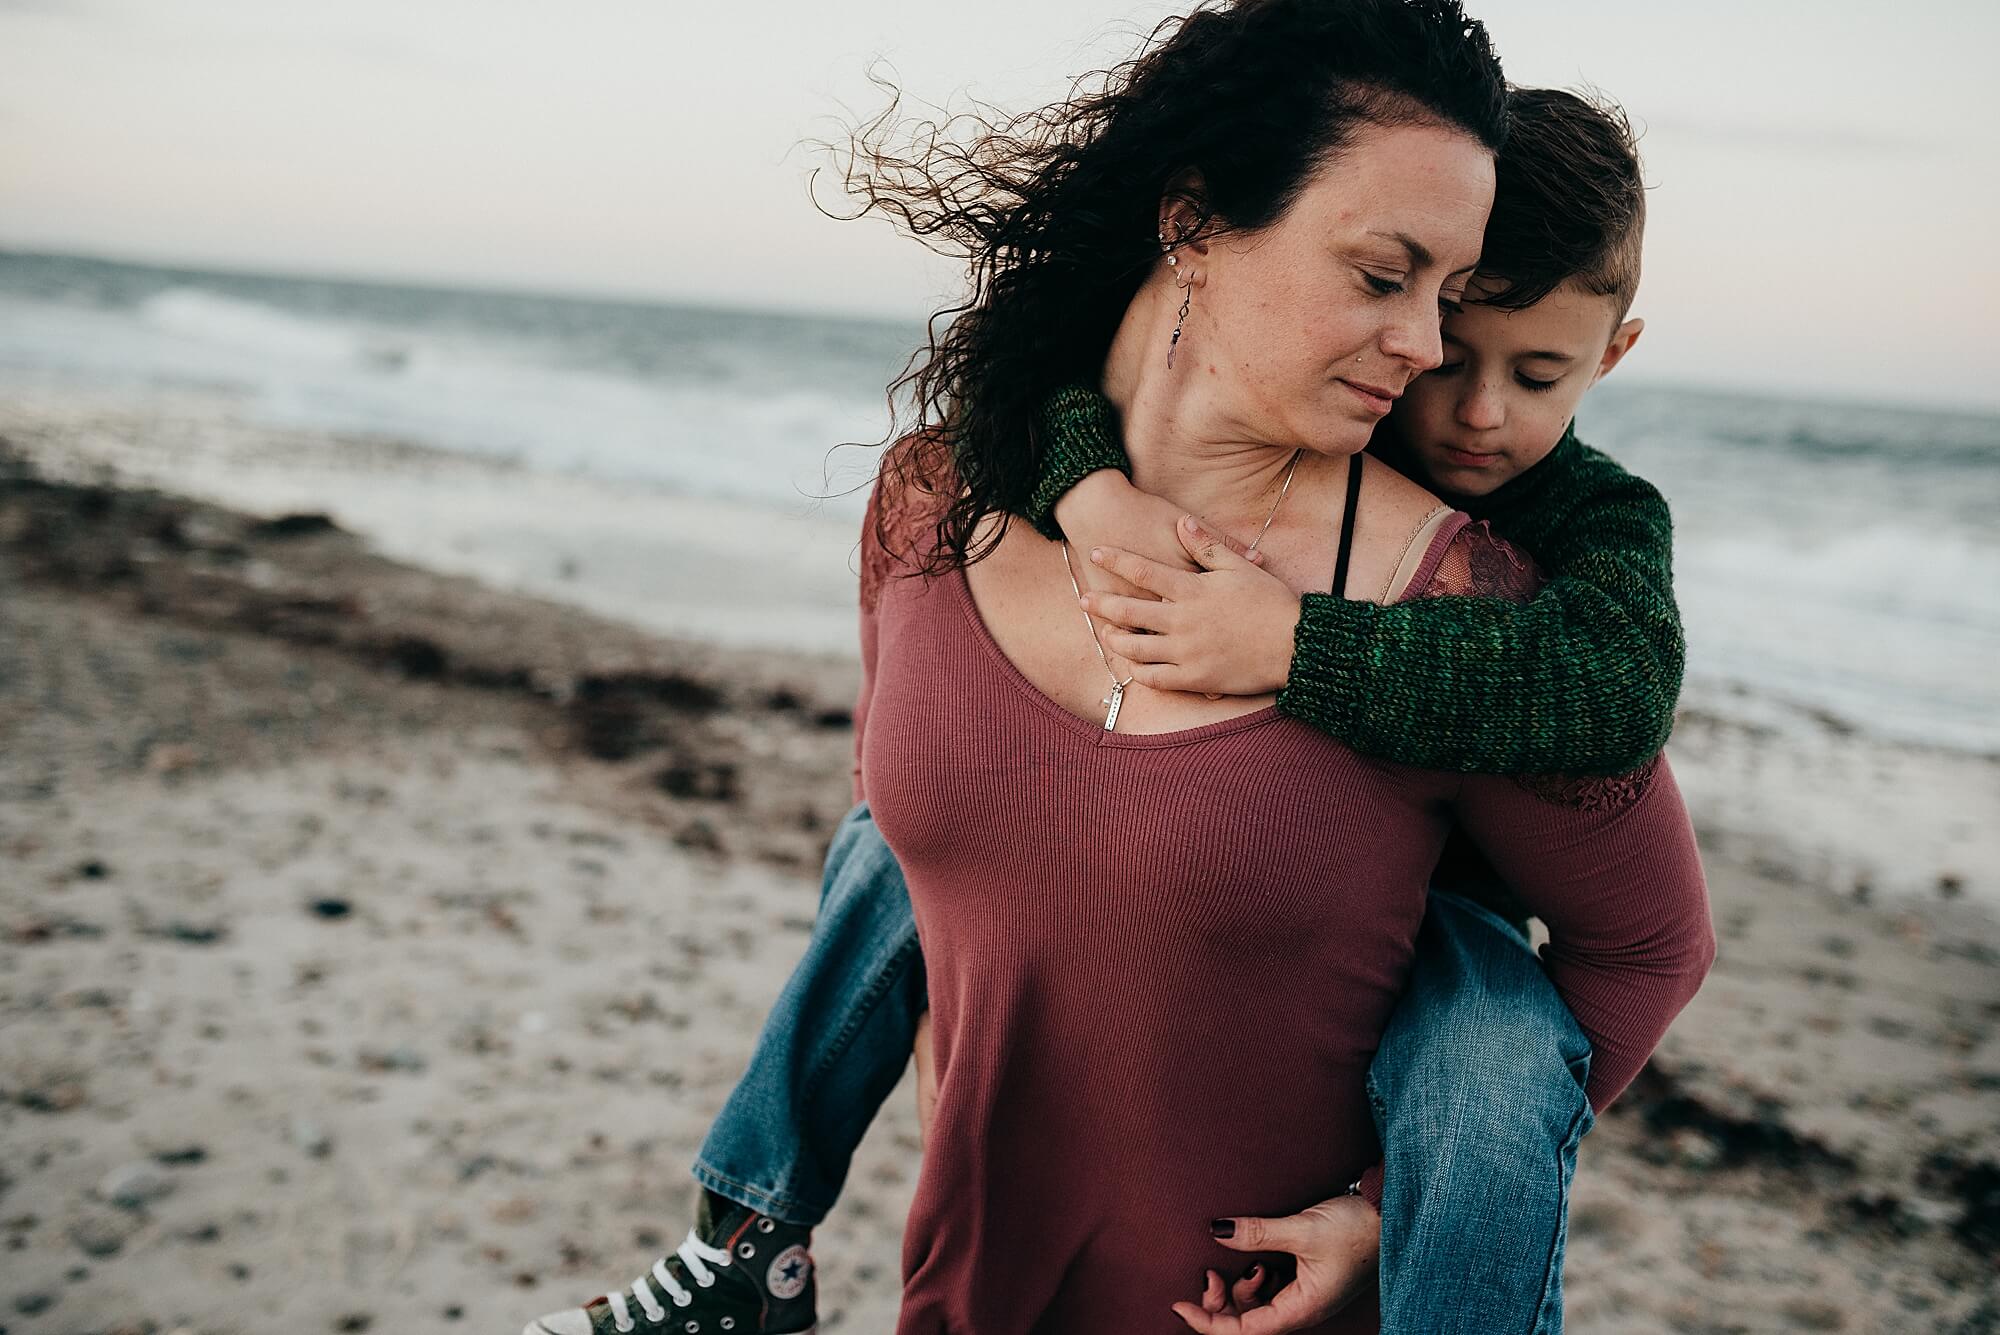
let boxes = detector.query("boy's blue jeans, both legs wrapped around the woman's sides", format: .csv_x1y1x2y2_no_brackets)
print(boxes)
694,801,1592,1335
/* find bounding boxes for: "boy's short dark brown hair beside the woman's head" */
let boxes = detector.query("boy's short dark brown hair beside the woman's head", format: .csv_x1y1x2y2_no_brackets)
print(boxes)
1478,88,1646,320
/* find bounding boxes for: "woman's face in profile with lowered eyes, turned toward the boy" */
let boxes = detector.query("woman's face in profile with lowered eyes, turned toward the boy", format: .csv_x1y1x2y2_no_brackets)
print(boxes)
1168,124,1494,456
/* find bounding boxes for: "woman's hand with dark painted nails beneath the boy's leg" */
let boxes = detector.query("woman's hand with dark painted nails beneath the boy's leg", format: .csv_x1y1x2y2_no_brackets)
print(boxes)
1174,1195,1382,1335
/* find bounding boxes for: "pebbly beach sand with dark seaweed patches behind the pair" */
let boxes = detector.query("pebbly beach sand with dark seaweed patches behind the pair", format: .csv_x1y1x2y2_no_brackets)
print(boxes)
0,421,2000,1335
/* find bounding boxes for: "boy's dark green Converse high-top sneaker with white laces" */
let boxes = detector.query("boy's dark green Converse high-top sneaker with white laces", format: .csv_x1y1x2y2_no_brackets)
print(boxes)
522,1191,818,1335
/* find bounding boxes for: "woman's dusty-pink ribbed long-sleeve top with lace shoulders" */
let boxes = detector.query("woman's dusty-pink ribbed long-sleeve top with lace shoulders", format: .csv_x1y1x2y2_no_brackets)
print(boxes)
856,469,1714,1335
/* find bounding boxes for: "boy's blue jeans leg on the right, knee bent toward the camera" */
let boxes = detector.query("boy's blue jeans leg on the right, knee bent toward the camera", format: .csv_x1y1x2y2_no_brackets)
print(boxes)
1368,891,1594,1335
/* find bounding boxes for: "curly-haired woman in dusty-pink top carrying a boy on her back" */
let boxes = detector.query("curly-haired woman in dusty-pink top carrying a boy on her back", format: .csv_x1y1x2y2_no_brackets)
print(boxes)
856,0,1712,1335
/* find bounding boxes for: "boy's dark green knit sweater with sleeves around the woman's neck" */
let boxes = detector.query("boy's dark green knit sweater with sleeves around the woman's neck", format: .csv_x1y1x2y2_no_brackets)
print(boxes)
1022,386,1686,775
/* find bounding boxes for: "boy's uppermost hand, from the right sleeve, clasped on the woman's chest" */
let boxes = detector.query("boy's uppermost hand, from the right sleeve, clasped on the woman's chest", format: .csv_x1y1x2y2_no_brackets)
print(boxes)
1082,516,1300,695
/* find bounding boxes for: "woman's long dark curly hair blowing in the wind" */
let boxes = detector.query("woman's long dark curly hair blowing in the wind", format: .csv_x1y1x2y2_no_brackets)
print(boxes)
812,0,1506,574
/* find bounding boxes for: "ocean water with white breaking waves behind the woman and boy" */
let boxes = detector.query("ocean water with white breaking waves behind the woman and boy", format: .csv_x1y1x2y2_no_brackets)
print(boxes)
0,244,2000,759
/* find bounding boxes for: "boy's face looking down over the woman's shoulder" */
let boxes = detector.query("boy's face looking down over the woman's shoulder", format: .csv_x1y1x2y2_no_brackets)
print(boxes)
1394,278,1644,496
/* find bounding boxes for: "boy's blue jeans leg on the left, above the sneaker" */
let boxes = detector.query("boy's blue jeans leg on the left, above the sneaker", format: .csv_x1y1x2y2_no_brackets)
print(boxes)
694,801,928,1227
